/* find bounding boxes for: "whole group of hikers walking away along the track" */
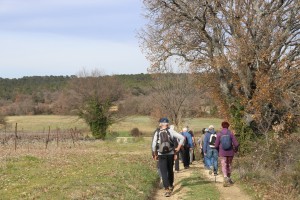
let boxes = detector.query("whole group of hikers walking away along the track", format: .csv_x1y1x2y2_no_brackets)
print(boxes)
152,117,239,197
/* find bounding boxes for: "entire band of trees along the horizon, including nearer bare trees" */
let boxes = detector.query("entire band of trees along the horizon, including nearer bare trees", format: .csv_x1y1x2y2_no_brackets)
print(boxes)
0,70,217,134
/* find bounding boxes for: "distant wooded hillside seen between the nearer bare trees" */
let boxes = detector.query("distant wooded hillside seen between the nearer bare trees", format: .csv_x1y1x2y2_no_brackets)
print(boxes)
0,74,216,117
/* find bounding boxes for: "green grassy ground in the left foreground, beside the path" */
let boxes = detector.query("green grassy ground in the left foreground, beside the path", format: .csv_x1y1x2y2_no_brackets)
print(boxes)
0,141,157,199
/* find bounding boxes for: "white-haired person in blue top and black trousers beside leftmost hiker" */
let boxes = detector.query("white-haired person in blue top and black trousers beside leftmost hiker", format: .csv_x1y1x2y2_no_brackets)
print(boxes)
181,127,194,169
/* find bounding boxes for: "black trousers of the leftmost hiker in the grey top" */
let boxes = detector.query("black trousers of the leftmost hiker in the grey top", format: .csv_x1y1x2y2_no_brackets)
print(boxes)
158,154,174,188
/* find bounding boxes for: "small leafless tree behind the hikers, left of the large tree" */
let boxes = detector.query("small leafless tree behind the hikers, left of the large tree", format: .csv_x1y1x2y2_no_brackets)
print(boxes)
152,70,203,127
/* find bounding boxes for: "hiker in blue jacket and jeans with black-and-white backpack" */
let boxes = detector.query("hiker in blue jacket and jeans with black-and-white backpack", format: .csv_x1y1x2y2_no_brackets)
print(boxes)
203,125,219,176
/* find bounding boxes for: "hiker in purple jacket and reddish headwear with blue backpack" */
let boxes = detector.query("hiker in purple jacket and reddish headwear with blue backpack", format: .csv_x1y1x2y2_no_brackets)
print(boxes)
215,121,239,187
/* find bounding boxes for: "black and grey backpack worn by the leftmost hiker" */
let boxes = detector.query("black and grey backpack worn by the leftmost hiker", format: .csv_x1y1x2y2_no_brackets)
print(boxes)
157,129,174,154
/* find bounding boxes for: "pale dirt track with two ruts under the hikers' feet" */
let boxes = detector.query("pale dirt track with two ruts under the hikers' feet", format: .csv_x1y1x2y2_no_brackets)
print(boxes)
154,161,250,200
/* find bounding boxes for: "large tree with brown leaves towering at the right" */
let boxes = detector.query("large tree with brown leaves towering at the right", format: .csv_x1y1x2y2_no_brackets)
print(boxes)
139,0,300,134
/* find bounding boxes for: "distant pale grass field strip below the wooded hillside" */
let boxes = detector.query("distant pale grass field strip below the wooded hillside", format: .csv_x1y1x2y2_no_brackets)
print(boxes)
7,115,222,136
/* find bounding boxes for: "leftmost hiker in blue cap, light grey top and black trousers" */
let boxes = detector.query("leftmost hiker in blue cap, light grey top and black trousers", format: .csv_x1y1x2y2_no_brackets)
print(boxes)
152,117,184,197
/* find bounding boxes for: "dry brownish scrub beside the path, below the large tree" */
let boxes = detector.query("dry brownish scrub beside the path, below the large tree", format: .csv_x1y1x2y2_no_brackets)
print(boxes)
236,136,300,200
